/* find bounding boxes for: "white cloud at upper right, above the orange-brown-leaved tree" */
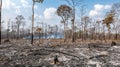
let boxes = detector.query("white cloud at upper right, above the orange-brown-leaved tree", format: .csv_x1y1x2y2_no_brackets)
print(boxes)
89,4,111,17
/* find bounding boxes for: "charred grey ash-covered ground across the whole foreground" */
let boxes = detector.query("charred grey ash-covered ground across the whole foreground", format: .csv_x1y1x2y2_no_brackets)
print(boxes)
0,41,120,67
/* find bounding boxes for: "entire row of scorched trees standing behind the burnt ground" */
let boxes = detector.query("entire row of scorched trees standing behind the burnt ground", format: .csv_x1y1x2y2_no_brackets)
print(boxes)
0,0,120,44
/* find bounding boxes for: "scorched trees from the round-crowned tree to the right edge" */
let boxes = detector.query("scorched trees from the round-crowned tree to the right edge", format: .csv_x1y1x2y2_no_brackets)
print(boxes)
57,0,120,42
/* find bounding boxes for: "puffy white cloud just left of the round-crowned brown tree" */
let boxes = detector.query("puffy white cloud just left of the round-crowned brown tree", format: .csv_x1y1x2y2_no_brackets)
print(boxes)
34,7,60,25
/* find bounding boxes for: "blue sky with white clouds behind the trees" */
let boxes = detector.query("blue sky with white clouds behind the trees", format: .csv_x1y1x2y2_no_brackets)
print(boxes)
2,0,120,27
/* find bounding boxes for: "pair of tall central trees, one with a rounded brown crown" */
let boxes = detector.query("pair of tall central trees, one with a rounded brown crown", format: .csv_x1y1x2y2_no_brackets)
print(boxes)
57,0,82,42
